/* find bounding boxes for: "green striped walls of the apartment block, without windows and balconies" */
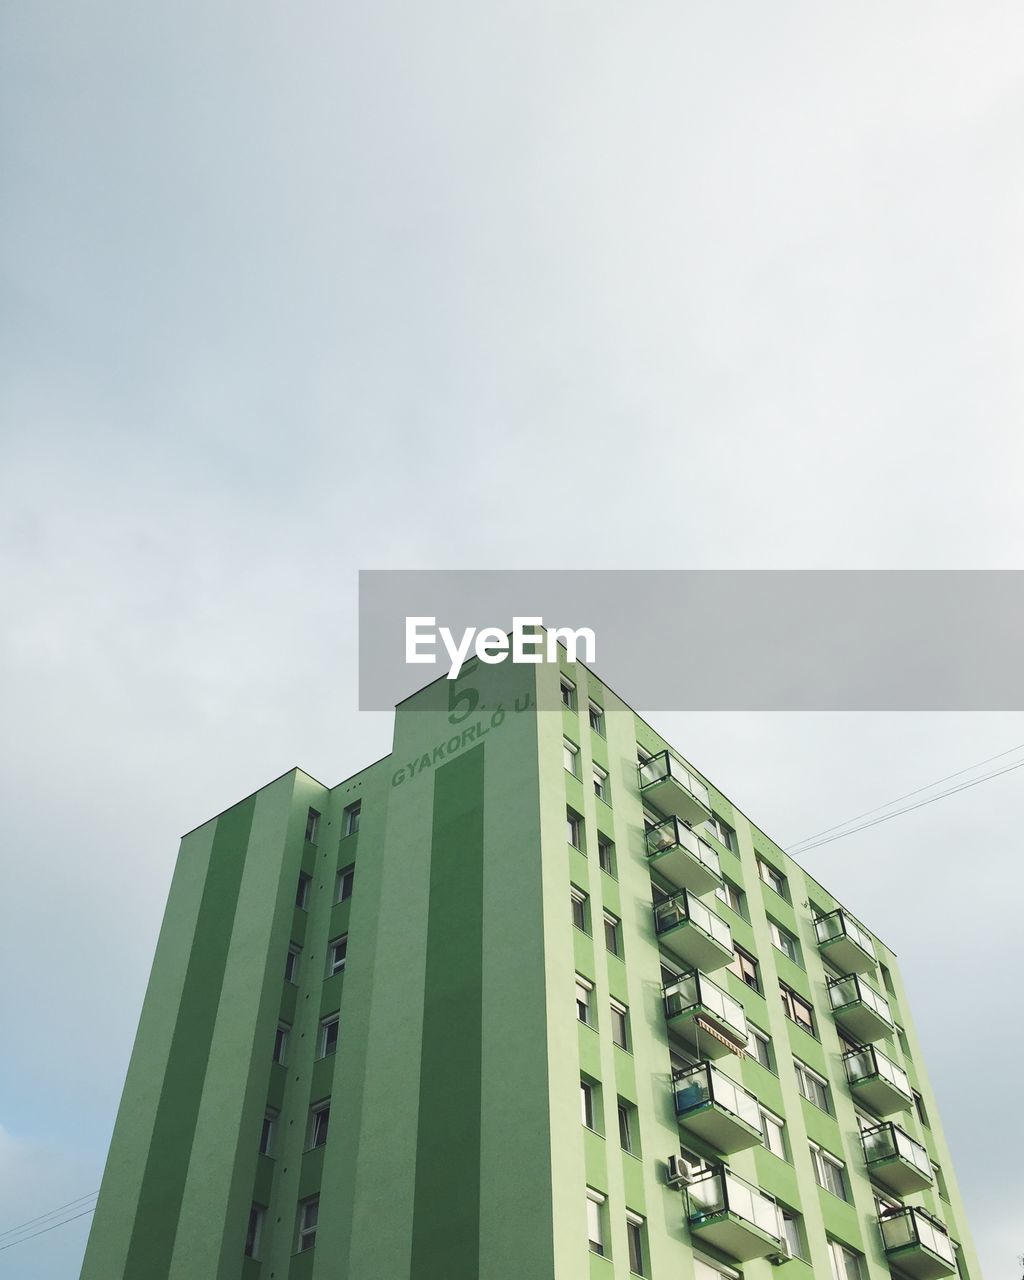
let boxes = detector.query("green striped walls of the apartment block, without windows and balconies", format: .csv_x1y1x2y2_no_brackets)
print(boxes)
82,650,979,1280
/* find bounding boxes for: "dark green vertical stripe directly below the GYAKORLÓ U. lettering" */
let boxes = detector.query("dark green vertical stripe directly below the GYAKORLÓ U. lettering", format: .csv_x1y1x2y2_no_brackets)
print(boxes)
410,745,484,1280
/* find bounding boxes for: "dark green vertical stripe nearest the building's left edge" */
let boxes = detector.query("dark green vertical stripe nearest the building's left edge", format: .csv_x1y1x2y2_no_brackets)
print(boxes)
122,796,256,1280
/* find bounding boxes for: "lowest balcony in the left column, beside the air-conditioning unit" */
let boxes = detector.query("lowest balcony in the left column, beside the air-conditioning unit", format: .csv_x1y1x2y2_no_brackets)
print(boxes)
686,1165,783,1262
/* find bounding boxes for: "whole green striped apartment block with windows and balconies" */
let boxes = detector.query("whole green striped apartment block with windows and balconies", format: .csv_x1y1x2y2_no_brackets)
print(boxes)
82,663,979,1280
